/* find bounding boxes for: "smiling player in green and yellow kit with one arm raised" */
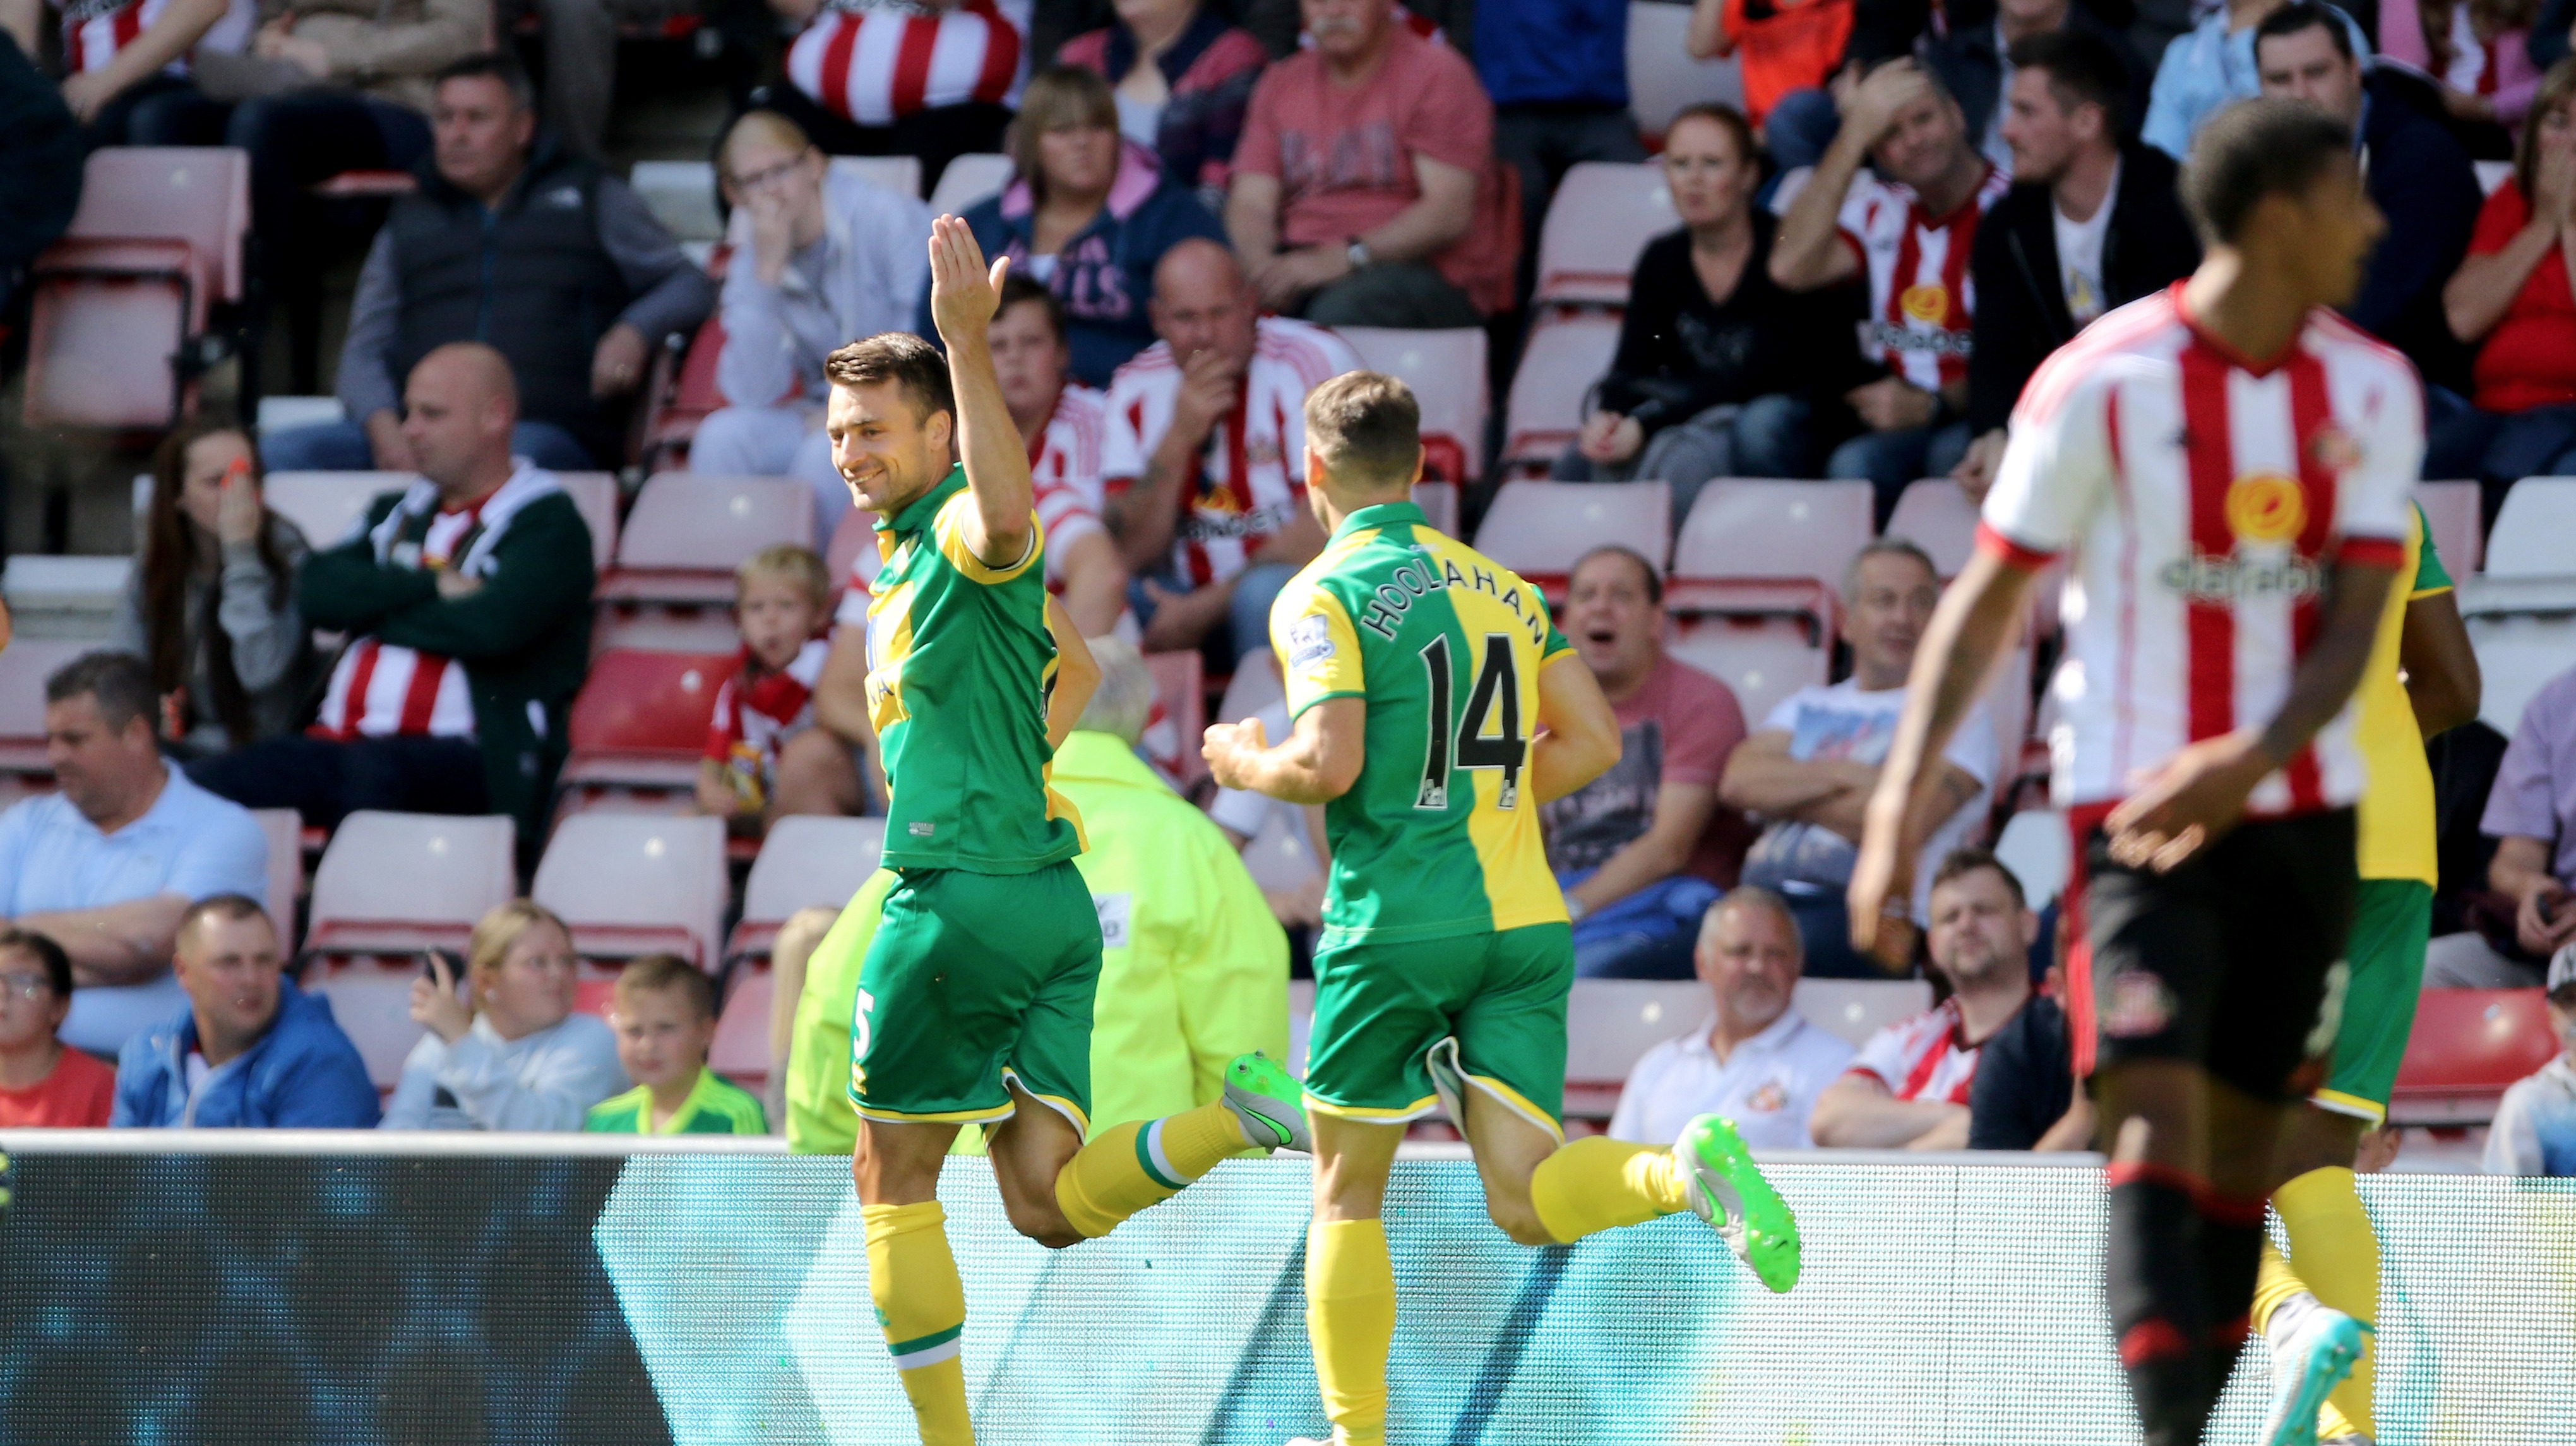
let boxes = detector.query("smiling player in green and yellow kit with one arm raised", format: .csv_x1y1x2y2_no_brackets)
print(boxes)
825,217,1303,1446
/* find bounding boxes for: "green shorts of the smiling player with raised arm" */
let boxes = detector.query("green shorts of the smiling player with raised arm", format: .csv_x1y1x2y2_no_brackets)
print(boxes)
850,861,1100,1134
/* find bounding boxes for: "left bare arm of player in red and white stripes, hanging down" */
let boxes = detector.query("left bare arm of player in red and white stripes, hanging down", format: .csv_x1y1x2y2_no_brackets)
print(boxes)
1849,546,2037,953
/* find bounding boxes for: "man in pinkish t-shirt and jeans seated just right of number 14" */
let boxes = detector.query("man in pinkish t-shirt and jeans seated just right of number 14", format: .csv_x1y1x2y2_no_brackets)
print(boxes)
1538,546,1751,979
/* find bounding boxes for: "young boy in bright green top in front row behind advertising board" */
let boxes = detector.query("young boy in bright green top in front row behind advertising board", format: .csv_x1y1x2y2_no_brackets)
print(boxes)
582,953,770,1134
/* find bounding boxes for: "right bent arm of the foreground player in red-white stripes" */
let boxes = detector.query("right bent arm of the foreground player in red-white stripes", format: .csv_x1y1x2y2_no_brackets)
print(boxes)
2102,557,2398,874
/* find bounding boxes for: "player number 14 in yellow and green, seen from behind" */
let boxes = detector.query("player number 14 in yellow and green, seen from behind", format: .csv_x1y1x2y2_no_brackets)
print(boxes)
1203,371,1798,1446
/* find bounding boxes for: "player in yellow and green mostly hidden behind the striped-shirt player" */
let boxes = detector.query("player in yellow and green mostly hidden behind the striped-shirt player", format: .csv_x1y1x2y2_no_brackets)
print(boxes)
2254,499,2478,1446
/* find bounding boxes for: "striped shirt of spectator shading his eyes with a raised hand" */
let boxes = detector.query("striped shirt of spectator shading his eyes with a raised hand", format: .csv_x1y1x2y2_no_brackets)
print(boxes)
1842,165,2012,391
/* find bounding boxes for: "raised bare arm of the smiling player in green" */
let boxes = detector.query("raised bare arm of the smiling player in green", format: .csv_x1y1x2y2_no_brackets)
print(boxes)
930,217,1038,567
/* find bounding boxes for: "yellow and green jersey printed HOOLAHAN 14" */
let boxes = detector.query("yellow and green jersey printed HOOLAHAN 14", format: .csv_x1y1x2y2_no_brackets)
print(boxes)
1270,503,1579,948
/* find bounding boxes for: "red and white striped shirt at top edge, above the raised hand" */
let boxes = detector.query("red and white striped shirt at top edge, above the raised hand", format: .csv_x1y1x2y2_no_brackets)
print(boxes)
788,0,1030,126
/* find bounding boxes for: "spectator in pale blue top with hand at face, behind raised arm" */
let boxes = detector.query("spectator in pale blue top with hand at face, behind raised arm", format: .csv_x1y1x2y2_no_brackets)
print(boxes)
688,111,930,539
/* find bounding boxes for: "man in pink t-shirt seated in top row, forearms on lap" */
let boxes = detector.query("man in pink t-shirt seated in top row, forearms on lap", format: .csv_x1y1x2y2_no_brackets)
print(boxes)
1226,0,1520,327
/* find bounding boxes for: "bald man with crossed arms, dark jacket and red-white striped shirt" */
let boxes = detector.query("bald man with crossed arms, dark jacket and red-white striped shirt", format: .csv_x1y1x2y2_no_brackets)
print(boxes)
188,343,592,845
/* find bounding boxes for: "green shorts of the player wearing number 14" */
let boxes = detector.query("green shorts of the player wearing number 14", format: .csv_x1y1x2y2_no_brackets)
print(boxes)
1306,923,1574,1134
